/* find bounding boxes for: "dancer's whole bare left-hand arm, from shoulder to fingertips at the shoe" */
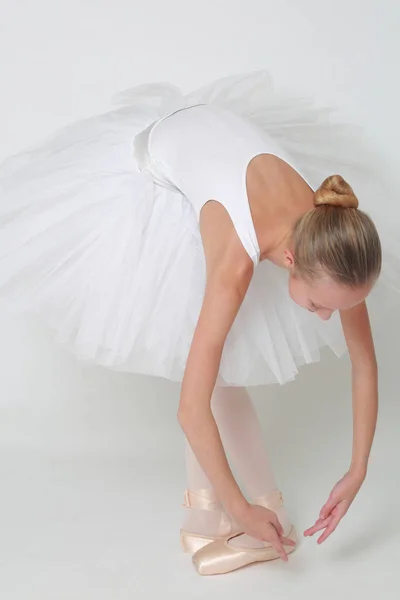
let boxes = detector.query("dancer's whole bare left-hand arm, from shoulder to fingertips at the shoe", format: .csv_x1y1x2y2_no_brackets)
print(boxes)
178,202,294,560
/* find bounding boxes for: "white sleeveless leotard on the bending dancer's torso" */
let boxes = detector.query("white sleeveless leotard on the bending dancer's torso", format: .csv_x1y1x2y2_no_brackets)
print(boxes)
135,104,310,265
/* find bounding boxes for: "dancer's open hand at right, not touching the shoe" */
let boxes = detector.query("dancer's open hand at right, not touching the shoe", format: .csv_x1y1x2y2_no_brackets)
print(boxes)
304,471,365,544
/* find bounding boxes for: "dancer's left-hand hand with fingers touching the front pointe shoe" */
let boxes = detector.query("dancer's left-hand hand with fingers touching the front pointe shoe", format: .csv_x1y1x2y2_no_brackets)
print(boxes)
237,504,296,561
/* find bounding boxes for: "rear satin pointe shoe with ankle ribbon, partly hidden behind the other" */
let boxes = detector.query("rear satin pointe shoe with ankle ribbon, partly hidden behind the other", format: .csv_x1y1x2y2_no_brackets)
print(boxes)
180,489,242,554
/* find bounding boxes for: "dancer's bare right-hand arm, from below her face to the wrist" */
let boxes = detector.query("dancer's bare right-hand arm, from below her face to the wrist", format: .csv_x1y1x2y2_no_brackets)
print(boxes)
341,302,378,477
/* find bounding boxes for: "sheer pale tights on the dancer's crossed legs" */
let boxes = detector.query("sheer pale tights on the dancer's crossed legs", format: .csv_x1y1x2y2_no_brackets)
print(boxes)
183,387,287,547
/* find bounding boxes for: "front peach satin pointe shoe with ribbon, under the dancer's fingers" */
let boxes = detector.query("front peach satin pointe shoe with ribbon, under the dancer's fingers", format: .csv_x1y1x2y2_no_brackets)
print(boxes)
192,490,297,575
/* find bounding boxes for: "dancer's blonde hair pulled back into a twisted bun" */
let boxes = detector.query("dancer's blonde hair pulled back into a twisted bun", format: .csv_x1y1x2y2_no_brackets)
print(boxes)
293,175,382,288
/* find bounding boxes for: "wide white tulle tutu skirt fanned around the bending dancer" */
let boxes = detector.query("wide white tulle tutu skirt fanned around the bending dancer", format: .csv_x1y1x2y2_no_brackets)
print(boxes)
0,72,400,385
